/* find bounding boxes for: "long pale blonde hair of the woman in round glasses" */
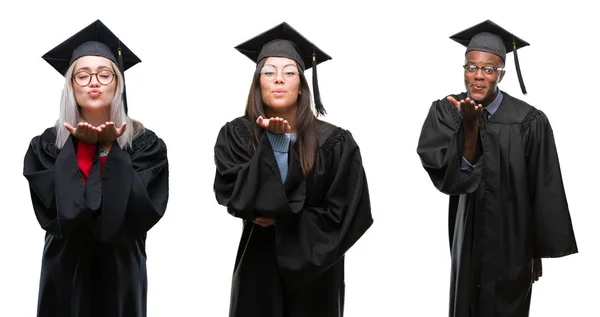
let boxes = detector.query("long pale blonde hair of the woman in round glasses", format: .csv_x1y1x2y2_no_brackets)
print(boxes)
55,61,144,149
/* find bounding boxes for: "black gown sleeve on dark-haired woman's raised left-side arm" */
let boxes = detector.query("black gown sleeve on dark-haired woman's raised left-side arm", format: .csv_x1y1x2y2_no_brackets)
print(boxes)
214,118,305,220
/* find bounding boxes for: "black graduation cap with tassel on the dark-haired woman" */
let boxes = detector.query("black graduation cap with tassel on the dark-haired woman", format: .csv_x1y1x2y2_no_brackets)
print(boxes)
235,22,331,115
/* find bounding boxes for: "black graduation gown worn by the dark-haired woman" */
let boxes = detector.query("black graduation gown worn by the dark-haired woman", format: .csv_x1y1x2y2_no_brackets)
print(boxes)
214,118,373,317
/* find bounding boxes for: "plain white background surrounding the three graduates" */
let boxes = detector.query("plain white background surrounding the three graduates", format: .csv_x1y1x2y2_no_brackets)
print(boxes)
0,1,600,317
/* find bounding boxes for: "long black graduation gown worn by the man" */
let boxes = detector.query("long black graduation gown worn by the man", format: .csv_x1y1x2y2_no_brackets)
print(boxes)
417,92,577,317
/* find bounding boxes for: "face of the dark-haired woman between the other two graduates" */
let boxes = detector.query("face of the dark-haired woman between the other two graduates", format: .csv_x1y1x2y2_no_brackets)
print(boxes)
260,57,301,111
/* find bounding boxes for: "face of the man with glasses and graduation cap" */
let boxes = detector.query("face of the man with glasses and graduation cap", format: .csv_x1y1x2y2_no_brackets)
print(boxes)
465,51,504,106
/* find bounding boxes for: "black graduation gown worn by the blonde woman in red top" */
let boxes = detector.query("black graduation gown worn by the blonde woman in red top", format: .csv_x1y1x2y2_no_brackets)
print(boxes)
23,128,169,317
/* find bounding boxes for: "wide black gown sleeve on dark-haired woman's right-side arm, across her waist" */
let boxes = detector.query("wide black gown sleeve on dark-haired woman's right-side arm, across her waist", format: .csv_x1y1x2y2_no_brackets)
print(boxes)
275,128,373,287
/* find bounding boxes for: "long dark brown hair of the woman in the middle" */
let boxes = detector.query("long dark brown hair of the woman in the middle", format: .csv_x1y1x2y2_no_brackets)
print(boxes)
246,59,318,175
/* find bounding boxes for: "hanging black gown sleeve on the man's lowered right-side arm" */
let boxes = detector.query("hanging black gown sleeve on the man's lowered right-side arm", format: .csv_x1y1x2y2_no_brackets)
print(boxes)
524,108,578,258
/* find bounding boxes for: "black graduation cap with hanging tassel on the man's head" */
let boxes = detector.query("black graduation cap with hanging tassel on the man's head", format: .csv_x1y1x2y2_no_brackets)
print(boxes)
450,20,529,95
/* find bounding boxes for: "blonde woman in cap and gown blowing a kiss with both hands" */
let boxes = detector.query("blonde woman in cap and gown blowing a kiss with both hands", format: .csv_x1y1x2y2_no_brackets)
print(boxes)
23,20,169,317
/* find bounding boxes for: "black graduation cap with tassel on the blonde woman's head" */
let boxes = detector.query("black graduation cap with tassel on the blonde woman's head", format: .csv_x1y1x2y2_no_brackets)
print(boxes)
42,20,141,113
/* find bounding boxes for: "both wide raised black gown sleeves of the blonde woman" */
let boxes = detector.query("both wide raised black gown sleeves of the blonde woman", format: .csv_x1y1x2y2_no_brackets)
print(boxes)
24,130,168,243
